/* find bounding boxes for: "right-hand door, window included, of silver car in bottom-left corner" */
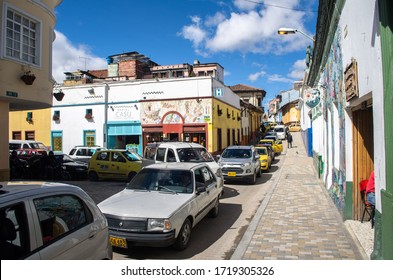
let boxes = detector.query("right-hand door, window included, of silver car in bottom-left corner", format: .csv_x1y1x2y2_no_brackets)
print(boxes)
29,194,107,260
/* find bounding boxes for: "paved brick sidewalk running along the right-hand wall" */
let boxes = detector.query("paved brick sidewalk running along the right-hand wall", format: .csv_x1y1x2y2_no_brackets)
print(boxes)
231,132,365,260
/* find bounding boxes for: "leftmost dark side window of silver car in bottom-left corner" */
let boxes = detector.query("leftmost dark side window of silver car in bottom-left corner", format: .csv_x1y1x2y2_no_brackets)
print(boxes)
0,203,30,260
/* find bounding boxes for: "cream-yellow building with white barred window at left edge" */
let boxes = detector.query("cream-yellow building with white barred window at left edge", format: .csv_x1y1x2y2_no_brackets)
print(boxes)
0,0,62,180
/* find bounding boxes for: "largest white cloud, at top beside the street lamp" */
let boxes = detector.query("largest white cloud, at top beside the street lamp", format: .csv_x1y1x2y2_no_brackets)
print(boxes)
179,0,309,54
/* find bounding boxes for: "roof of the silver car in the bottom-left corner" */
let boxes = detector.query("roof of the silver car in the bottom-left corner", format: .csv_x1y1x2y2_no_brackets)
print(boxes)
0,181,81,203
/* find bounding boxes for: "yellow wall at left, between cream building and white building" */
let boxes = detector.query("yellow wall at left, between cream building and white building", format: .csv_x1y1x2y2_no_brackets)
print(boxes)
9,109,52,146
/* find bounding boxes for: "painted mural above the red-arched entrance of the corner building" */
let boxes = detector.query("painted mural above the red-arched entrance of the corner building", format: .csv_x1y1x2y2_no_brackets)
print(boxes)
140,99,211,124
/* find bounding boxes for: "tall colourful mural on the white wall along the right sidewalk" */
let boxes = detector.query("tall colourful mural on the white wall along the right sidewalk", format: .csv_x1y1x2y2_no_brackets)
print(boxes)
322,28,346,214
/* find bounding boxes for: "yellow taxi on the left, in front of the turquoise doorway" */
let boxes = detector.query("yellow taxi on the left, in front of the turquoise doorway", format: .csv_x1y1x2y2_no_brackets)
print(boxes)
87,149,142,181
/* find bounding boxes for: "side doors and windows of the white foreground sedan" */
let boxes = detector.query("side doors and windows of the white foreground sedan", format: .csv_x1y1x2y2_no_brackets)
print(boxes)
194,166,219,222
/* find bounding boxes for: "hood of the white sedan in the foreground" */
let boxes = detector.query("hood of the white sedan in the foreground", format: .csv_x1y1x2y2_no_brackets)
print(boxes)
98,189,193,218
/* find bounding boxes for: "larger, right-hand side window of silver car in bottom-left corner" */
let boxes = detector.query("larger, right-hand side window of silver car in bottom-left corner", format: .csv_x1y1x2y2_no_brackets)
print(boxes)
34,195,93,244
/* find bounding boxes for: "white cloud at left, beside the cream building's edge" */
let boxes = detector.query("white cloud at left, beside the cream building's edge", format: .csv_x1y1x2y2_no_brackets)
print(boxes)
52,31,107,83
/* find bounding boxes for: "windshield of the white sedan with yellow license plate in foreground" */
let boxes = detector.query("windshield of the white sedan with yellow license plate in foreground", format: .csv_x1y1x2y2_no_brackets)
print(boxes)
126,168,193,193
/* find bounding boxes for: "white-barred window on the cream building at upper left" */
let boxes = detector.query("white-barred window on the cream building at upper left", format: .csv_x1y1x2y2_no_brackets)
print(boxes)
5,7,40,65
